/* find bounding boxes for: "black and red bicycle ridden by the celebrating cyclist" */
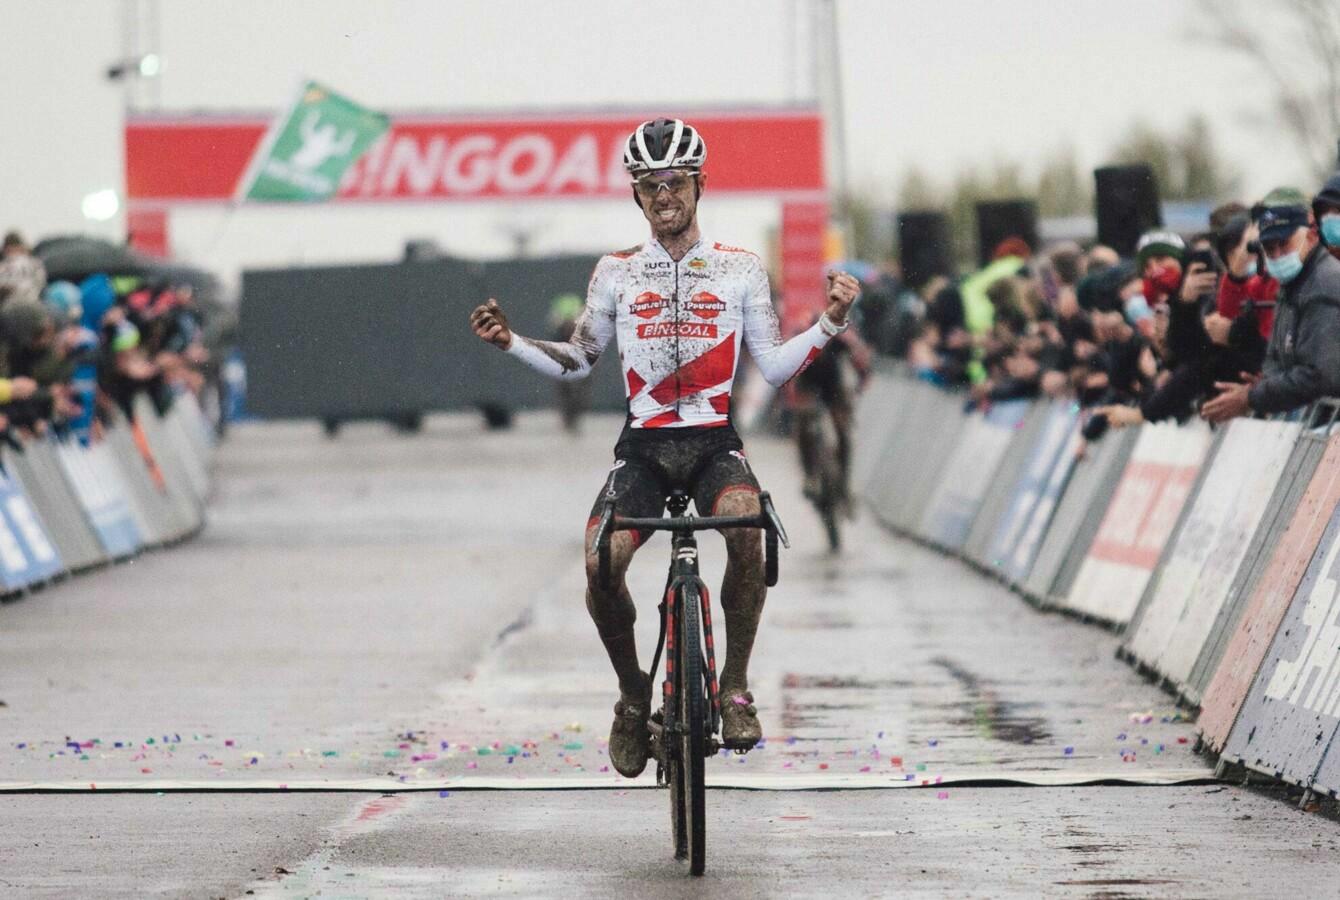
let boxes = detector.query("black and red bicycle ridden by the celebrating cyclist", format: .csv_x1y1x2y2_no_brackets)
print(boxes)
594,490,791,875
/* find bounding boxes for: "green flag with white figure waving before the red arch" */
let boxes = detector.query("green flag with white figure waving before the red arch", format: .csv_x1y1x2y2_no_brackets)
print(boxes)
237,82,390,202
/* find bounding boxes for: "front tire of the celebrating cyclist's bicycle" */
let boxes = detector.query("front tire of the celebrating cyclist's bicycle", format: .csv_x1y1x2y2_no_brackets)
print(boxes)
675,584,708,875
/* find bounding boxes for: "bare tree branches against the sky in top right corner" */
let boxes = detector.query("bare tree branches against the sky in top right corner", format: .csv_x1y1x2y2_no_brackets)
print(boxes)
1194,0,1340,178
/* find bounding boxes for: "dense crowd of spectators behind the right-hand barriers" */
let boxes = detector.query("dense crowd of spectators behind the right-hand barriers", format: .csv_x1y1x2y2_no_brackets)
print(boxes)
867,174,1340,439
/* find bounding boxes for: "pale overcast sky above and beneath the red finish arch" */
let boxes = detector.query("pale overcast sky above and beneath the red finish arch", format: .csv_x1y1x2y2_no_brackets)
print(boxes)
0,0,1312,286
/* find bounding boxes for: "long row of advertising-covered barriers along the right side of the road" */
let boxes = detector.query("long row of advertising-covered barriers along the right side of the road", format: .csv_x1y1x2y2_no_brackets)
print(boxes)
860,376,1340,797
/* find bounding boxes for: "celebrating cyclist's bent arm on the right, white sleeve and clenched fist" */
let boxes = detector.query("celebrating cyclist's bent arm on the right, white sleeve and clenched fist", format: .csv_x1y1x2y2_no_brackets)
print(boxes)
745,259,859,387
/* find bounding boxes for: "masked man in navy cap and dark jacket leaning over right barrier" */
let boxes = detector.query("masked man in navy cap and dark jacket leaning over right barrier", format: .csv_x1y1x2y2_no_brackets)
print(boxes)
1201,188,1340,422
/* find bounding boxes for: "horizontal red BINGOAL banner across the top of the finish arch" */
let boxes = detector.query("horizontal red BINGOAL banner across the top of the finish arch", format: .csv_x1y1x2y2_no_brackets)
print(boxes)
126,110,824,204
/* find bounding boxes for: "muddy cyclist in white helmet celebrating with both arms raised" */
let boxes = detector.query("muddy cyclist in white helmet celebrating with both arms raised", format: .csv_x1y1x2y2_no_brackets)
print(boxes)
470,118,859,778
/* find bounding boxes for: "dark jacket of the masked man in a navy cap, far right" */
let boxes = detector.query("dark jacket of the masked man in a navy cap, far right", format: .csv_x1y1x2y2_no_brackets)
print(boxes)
1248,244,1340,413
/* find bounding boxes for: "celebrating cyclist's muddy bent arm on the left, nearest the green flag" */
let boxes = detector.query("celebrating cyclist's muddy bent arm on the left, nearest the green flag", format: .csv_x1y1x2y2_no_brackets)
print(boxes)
470,260,615,382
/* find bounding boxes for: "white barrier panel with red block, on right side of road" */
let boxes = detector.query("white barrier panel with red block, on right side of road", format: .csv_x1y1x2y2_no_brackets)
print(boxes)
1065,421,1210,625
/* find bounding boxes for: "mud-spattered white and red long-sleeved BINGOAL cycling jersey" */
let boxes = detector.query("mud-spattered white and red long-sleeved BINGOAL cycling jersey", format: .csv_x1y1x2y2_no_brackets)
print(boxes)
508,240,828,429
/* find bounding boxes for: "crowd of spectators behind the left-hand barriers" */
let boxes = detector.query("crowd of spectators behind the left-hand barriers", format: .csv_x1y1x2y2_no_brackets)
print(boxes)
0,232,209,442
